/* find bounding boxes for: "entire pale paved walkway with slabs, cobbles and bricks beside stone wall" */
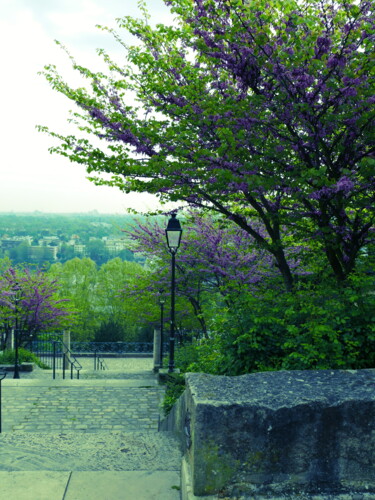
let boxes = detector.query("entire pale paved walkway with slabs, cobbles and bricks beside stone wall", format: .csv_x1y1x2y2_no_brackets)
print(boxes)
0,359,181,500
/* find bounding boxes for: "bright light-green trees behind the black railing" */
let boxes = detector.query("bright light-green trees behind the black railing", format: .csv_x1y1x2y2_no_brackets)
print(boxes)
48,257,159,341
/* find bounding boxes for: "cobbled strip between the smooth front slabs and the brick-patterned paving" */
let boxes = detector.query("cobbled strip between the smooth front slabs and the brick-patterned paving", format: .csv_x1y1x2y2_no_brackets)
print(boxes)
0,432,181,472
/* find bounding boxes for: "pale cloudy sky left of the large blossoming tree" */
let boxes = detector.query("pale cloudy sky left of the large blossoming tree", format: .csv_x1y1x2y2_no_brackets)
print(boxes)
0,0,173,213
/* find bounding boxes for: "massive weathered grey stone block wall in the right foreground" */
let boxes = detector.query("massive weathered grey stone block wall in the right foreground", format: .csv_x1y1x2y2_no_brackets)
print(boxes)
162,370,375,498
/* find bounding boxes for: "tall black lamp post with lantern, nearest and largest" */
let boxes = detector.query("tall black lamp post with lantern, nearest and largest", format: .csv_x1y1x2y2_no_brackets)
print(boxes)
165,214,182,373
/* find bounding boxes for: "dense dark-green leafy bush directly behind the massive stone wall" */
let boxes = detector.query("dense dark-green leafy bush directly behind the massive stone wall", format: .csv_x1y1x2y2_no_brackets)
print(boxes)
219,275,375,375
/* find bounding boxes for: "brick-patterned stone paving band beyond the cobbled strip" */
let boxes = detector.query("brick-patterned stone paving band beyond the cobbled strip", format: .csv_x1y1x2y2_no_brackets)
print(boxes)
2,378,164,433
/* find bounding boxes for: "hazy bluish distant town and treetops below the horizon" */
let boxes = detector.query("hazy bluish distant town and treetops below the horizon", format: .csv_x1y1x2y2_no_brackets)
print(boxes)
0,213,149,265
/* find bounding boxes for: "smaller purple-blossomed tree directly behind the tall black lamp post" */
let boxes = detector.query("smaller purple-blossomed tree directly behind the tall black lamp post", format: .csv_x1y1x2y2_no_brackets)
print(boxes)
126,211,306,334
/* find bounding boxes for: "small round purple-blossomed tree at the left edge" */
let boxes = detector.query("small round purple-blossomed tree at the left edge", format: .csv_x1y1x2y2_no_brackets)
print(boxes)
0,267,70,348
